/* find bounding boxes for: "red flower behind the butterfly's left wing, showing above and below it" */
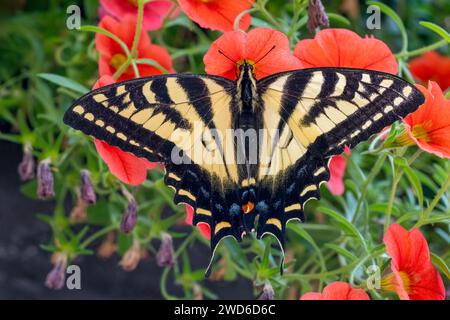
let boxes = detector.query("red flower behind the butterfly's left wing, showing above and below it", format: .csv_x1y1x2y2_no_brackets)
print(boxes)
93,76,160,185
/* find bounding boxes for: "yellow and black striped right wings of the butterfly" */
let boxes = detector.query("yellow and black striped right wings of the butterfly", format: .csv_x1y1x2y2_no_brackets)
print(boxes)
258,68,424,250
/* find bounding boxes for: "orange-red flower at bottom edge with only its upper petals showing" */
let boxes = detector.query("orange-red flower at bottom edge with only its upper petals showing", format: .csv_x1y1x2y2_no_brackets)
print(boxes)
300,281,370,300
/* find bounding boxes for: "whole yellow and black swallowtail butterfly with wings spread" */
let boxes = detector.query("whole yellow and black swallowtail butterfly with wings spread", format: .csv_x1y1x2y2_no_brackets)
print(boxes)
64,61,424,276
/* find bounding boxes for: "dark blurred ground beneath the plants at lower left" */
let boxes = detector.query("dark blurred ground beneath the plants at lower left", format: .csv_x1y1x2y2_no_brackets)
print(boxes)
0,141,253,299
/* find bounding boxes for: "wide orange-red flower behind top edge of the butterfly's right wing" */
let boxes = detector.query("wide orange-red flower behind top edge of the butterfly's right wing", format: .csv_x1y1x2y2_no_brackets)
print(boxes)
294,29,398,74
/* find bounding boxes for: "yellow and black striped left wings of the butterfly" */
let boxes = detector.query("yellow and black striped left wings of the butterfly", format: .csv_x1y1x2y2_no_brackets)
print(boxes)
64,74,243,238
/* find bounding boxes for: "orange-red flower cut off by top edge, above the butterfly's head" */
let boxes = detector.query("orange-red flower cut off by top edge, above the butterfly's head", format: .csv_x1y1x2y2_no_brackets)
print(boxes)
178,0,254,31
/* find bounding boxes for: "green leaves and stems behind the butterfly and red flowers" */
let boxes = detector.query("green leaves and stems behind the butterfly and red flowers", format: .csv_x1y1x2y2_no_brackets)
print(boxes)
0,0,450,298
